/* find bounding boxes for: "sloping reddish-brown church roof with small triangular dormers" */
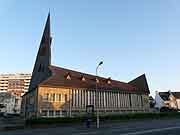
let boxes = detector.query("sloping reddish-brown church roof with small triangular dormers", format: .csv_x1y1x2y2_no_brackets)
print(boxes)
40,66,149,92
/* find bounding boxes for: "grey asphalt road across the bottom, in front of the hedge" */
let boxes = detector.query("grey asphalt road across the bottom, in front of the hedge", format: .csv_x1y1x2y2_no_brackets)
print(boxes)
0,119,180,135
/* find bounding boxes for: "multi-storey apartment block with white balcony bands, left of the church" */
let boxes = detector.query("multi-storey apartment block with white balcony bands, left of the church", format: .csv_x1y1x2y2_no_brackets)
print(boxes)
0,73,31,96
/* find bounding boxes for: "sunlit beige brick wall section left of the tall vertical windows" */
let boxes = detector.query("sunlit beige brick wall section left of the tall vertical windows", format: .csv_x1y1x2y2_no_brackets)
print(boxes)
38,87,70,116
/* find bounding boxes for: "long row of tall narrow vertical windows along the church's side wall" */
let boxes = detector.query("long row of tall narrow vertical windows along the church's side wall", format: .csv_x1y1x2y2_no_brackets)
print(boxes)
72,90,143,108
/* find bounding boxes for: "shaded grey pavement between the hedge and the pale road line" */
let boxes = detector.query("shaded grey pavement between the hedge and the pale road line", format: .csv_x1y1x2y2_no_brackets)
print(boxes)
0,119,180,135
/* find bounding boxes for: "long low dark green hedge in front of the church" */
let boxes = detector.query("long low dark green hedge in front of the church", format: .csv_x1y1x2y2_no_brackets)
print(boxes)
26,112,180,125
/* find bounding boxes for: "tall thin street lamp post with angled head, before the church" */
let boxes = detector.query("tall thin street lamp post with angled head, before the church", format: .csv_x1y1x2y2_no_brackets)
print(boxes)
96,61,103,128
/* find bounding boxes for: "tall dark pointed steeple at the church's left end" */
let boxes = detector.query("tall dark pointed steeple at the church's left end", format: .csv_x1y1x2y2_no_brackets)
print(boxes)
29,12,51,90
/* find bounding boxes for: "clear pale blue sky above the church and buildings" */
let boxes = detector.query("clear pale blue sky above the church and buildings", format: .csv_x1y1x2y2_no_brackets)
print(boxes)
0,0,180,95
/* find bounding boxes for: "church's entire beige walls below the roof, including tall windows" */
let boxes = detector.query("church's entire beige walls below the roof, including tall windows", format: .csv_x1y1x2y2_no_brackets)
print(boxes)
21,86,149,117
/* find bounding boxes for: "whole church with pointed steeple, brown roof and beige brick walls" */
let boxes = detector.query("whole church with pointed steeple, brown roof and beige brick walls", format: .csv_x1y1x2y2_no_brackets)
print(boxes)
21,14,149,119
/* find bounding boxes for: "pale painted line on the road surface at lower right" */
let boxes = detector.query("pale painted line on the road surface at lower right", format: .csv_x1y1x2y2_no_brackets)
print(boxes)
121,127,180,135
